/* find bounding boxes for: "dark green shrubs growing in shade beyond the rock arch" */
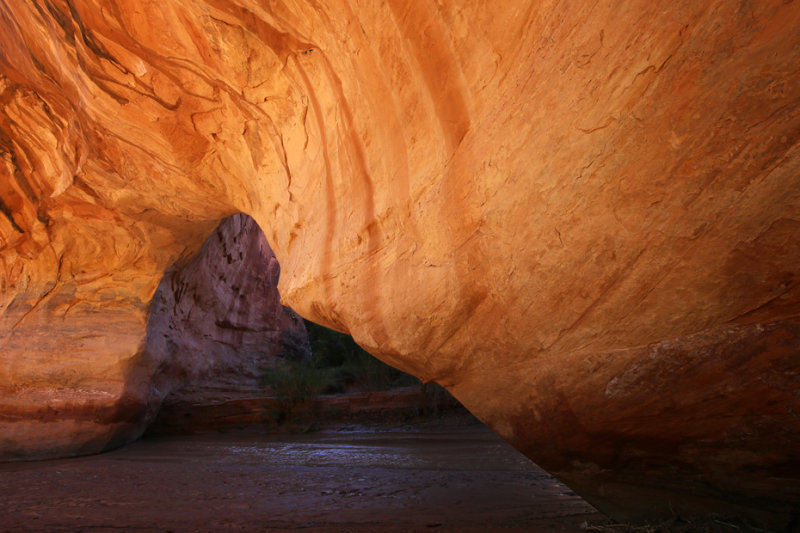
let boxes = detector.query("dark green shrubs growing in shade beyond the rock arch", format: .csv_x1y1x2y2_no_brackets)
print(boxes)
261,321,419,423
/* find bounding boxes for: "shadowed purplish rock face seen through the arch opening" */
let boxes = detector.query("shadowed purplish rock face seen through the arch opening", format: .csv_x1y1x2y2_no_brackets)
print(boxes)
145,211,311,427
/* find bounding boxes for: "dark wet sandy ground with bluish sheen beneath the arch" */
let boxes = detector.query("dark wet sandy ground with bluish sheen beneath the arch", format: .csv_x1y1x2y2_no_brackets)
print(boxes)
0,428,603,533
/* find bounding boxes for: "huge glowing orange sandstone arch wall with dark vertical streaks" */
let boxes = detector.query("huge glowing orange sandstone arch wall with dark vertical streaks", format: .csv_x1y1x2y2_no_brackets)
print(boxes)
0,0,800,528
